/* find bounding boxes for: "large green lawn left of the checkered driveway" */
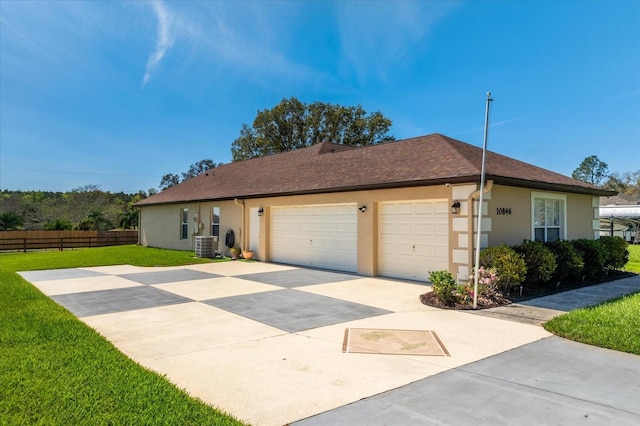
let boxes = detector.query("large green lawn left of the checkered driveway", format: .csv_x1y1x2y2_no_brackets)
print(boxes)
0,246,242,425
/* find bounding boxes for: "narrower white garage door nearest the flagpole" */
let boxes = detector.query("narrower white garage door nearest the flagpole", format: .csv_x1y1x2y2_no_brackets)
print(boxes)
378,200,449,281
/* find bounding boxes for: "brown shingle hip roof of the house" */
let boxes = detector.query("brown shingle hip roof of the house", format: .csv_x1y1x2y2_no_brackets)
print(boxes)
137,134,611,205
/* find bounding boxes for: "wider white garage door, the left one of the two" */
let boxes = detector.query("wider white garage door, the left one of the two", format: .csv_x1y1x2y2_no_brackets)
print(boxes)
271,204,358,272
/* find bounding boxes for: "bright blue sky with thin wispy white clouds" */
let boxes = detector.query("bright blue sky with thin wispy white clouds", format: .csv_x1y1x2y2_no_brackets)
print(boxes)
0,1,640,193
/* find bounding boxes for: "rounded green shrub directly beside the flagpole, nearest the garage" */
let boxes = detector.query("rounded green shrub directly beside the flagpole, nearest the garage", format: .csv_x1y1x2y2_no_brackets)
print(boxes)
480,245,527,292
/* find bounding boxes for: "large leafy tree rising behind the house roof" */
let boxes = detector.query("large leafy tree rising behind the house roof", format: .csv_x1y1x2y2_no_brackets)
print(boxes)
231,97,394,161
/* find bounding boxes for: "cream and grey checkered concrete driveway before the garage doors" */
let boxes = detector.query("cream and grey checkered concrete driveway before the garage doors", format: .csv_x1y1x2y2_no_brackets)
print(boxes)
21,262,564,425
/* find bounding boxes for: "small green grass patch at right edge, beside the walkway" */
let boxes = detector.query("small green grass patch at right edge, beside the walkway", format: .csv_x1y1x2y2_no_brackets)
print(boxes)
544,293,640,355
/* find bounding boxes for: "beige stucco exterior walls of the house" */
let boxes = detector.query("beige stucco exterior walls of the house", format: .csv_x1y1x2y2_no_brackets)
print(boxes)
140,183,597,279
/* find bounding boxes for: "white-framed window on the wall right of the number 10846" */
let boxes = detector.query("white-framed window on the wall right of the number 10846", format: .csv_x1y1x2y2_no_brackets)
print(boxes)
531,193,567,242
